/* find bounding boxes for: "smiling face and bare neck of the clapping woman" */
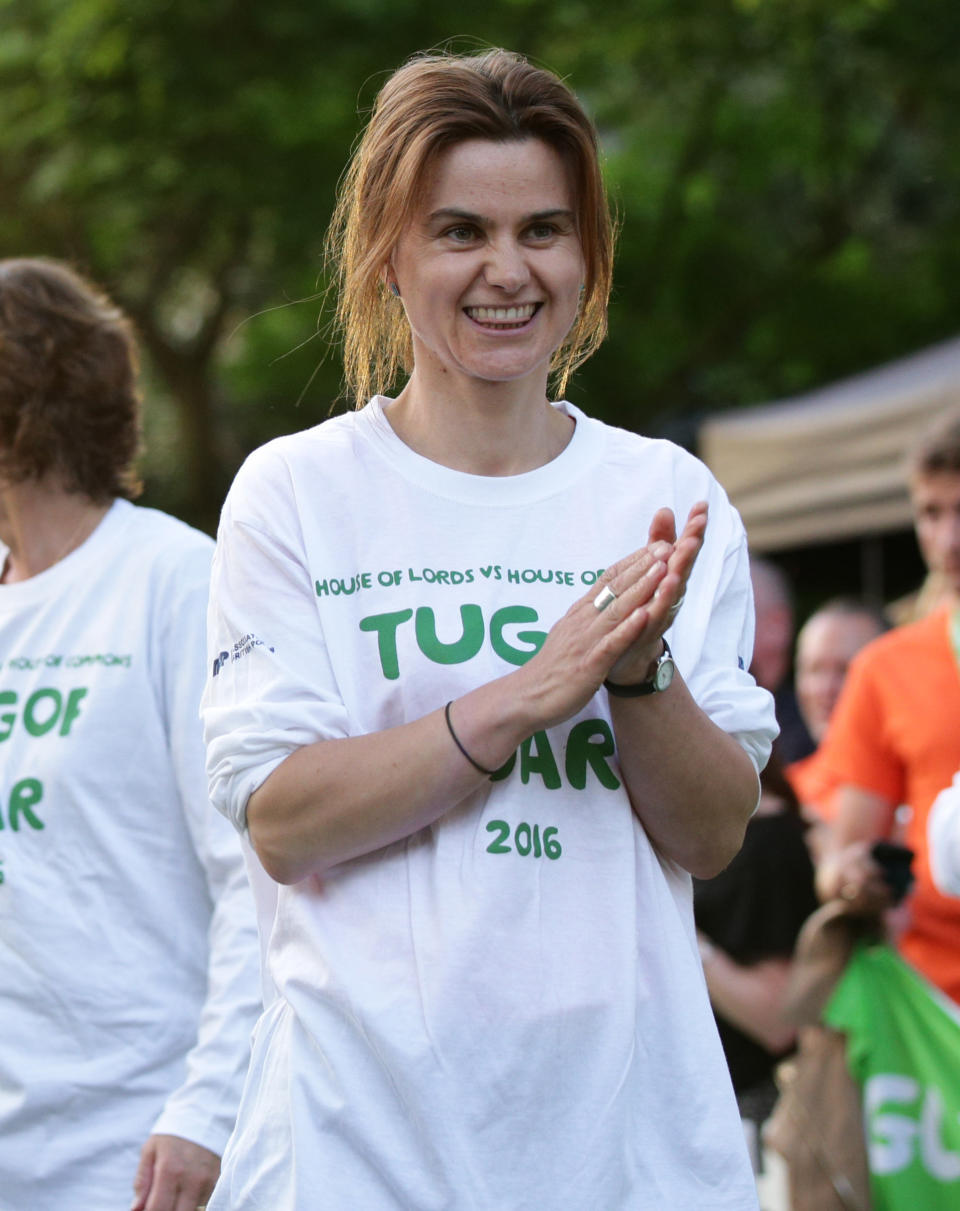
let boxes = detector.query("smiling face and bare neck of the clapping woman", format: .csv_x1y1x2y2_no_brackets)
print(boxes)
386,139,584,462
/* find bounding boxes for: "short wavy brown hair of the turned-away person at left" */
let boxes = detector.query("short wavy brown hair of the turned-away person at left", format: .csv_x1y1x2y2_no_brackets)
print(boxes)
0,257,140,501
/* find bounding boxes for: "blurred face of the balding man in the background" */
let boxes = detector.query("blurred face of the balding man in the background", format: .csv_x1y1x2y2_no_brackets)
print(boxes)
795,613,880,744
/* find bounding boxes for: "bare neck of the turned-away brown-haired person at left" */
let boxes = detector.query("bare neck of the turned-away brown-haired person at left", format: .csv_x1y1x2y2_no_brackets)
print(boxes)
0,480,110,585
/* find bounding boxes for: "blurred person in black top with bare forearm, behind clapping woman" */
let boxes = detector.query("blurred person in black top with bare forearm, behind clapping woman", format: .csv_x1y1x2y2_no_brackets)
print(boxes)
694,754,817,1169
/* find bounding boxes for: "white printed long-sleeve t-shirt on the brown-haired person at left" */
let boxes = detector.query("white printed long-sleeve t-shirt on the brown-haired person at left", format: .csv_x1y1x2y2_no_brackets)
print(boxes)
0,501,261,1211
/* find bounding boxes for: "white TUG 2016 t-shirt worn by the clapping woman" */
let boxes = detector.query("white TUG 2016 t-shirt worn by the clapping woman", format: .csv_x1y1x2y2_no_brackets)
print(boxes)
202,398,776,1211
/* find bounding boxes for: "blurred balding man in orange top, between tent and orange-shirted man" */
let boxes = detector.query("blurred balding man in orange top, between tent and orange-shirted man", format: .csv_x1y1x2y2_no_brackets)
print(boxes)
784,597,890,836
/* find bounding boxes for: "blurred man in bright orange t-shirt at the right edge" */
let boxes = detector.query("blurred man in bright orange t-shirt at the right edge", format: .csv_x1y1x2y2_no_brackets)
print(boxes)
817,417,960,1001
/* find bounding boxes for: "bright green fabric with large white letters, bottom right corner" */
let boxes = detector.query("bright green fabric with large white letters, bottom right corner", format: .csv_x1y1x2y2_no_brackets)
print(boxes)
823,946,960,1211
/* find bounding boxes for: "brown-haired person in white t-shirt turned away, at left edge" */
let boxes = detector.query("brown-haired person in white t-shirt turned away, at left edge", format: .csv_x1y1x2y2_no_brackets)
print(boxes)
0,259,259,1211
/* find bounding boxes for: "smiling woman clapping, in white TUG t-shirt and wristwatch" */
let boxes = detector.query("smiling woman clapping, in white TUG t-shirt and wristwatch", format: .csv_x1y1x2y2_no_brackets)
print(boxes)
203,44,776,1211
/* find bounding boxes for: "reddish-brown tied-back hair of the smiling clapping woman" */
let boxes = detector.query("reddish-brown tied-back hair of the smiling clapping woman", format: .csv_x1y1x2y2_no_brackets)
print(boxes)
327,50,616,407
